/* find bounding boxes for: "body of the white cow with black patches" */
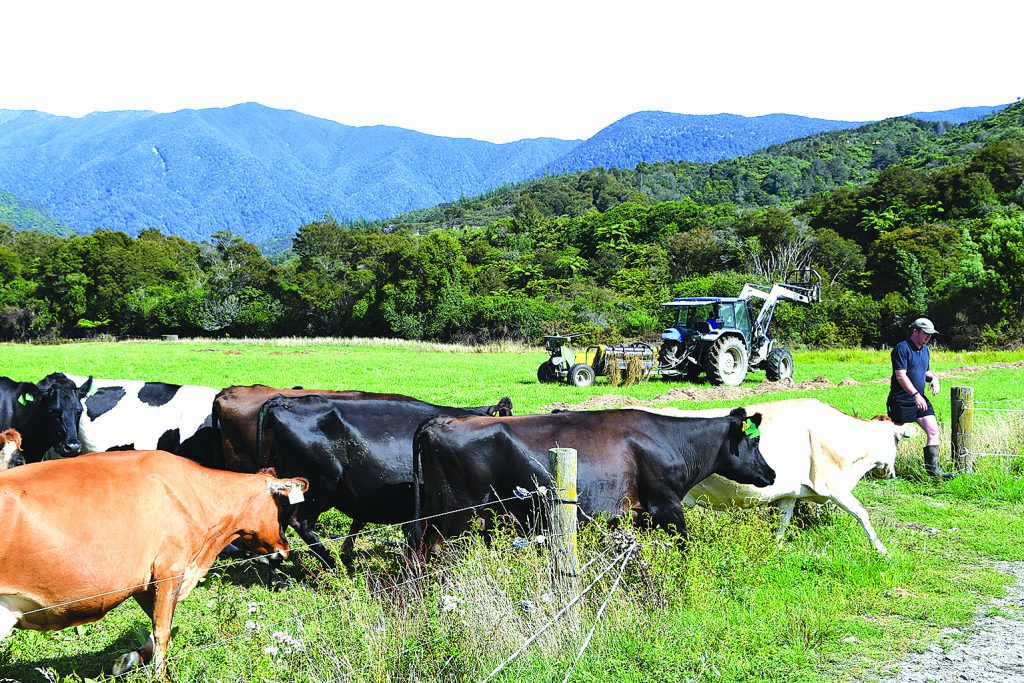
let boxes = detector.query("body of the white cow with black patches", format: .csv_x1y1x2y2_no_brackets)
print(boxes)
59,375,217,467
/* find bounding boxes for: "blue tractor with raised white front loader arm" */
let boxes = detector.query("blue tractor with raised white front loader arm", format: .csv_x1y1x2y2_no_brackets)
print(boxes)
658,269,821,386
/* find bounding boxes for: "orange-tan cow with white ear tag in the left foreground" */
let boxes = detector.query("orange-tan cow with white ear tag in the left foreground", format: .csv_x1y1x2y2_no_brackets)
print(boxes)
0,451,309,676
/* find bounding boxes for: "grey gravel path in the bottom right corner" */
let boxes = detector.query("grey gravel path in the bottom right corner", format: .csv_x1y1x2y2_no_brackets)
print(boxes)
881,562,1024,683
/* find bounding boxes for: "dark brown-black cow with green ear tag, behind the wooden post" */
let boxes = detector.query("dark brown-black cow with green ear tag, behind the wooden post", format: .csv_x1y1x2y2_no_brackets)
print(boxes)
406,409,775,555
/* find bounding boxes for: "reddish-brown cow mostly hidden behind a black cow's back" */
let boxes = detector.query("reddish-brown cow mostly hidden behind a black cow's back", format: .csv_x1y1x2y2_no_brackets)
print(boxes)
213,384,512,472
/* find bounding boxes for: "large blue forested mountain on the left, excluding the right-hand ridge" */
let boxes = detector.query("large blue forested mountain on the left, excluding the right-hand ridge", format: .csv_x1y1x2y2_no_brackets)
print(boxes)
0,103,579,242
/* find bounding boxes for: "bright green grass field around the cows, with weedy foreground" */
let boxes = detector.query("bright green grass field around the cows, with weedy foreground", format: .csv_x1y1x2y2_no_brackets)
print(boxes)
0,340,1024,682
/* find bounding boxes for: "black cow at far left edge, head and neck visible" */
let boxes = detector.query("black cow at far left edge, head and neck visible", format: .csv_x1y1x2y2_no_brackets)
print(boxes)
0,373,92,463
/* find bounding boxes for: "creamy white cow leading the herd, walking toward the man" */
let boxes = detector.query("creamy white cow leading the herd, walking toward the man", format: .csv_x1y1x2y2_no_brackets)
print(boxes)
640,398,921,554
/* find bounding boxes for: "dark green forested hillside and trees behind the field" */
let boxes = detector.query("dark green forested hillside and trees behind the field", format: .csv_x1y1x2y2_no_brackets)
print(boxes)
0,103,1024,347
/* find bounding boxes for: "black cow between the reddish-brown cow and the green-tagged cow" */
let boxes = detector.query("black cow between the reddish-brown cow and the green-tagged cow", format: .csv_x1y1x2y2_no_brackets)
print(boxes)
247,392,511,568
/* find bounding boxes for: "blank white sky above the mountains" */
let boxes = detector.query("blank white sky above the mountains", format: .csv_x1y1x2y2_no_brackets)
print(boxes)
0,0,1024,142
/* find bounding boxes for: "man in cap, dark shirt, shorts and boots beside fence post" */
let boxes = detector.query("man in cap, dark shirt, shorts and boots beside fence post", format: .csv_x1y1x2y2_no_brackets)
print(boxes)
888,317,953,479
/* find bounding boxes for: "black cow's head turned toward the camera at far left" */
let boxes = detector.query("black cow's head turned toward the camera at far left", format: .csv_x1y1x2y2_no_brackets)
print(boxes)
23,373,92,458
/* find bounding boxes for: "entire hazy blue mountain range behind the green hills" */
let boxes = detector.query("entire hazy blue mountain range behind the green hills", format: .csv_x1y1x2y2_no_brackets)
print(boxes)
0,103,1001,243
